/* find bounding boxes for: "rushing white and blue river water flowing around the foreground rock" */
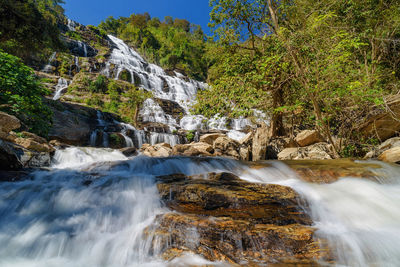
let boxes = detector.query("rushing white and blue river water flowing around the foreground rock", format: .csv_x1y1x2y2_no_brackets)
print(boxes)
0,148,400,267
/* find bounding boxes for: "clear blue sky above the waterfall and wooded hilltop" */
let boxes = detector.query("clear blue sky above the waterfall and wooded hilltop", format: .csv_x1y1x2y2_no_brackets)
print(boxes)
64,0,211,34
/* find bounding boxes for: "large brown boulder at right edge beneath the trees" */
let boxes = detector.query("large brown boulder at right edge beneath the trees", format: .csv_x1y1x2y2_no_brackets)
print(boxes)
357,95,400,141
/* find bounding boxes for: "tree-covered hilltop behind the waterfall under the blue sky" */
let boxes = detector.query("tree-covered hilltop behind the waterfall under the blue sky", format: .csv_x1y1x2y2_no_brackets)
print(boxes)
98,13,208,80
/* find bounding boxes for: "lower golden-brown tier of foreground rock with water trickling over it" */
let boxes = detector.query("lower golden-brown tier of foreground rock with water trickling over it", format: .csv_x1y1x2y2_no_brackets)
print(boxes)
153,213,327,266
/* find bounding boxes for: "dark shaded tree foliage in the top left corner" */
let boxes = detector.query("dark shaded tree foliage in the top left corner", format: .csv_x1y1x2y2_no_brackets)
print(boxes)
0,0,64,62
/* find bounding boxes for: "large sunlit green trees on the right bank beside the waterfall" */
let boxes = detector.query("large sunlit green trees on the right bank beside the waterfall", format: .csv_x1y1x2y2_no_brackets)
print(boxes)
196,0,400,155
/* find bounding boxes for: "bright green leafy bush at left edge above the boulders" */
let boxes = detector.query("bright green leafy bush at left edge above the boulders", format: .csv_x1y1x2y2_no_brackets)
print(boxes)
0,51,52,136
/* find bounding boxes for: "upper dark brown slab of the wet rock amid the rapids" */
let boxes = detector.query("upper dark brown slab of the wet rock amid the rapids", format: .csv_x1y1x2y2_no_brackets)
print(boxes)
157,173,311,225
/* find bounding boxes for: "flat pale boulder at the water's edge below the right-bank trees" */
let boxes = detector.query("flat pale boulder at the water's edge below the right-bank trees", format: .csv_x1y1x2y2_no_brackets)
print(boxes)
278,143,335,160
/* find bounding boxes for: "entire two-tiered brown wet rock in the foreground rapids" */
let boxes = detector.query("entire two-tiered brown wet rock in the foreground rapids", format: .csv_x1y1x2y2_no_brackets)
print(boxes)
151,173,329,266
